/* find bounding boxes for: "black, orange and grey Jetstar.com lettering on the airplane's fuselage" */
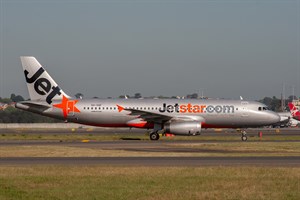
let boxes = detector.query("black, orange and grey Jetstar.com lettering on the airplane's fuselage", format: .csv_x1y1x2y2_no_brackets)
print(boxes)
159,103,234,113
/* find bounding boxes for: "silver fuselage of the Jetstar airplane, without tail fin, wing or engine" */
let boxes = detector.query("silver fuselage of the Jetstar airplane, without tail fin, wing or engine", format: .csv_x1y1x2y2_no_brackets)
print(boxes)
16,99,279,128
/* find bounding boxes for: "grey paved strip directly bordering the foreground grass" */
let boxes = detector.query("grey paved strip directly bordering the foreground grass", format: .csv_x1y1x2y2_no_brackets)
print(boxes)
0,156,300,167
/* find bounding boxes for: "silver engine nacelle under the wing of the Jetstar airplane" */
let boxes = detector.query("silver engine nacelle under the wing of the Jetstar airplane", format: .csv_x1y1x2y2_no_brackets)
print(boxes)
164,121,201,135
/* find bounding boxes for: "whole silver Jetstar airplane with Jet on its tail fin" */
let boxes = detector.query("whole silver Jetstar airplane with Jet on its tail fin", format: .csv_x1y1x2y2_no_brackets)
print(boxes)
15,56,280,141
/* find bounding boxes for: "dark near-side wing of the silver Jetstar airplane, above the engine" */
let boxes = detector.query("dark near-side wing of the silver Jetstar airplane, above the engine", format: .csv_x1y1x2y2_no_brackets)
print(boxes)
124,109,173,123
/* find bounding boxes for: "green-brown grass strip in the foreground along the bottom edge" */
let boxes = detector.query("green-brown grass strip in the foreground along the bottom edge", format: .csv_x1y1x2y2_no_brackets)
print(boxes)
0,165,300,200
